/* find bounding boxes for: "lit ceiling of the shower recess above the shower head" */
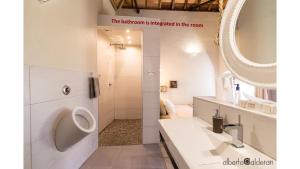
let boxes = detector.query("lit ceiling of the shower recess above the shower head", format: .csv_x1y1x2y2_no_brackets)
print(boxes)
101,27,142,45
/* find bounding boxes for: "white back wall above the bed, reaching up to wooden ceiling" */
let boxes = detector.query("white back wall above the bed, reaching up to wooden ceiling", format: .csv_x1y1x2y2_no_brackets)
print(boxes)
117,9,218,104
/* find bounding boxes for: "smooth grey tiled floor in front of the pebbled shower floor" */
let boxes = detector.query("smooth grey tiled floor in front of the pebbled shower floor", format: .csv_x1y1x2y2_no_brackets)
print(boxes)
81,144,166,169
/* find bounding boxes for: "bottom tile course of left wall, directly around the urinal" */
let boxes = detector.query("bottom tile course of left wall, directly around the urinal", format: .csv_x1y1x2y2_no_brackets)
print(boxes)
31,96,97,169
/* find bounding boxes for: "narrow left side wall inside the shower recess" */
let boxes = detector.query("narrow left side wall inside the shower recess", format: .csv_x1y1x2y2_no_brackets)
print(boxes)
97,30,116,132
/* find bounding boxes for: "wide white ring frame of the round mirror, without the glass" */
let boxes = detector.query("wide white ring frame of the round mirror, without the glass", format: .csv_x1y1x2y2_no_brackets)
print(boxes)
219,0,277,88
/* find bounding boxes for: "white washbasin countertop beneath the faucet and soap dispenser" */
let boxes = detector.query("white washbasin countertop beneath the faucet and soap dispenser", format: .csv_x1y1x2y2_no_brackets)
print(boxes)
159,117,276,169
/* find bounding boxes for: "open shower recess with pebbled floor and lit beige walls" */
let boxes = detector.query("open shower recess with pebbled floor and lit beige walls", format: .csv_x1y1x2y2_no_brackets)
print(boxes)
97,27,142,146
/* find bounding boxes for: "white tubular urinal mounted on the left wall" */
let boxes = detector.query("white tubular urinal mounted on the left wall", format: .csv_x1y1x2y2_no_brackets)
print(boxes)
55,107,96,152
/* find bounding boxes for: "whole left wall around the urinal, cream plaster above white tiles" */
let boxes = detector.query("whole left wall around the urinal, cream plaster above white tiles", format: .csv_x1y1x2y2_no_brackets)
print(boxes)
24,0,98,169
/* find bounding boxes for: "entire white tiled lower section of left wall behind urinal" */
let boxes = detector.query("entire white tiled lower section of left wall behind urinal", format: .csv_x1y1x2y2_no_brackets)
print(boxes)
24,66,98,169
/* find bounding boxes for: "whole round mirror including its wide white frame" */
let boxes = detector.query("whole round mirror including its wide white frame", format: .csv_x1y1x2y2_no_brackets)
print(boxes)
219,0,276,88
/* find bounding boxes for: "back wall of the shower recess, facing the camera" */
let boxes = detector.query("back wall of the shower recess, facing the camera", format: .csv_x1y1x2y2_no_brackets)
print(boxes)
114,46,142,119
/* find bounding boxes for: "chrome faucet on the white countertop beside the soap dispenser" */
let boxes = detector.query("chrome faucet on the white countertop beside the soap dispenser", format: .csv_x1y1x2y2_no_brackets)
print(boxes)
223,115,244,148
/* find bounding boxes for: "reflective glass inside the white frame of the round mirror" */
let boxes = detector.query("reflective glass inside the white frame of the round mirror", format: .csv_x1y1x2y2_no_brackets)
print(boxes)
235,0,276,64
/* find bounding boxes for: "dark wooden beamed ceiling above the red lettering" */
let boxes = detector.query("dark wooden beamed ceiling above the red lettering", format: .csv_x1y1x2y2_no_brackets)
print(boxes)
110,0,227,13
